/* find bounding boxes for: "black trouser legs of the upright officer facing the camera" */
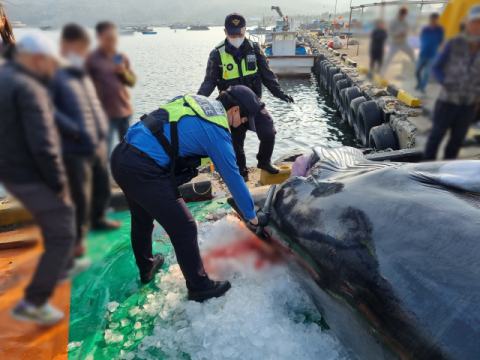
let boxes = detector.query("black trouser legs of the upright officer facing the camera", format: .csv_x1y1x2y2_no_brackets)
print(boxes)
232,105,277,176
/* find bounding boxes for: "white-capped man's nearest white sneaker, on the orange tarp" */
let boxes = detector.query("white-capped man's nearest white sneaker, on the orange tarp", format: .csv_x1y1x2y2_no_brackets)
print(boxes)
11,299,65,326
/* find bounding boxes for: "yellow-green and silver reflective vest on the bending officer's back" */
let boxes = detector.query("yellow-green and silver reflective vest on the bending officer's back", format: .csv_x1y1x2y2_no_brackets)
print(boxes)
160,94,230,132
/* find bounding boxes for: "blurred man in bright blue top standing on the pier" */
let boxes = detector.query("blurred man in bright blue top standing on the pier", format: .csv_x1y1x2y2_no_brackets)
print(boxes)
415,13,444,93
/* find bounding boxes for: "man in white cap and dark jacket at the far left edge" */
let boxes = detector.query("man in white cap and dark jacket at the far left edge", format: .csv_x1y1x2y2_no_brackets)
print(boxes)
0,34,75,325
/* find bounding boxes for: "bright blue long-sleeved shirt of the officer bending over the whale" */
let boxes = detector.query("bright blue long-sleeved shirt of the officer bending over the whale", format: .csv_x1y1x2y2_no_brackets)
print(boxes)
127,116,255,220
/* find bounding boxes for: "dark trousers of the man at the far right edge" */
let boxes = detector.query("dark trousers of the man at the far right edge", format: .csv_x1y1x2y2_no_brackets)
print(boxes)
423,100,475,160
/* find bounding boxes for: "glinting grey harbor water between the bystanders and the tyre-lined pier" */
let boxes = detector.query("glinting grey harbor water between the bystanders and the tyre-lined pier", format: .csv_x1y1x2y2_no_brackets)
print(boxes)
11,27,355,166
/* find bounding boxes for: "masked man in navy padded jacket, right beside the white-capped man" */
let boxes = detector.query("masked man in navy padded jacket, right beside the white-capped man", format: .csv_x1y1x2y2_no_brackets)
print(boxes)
50,24,120,257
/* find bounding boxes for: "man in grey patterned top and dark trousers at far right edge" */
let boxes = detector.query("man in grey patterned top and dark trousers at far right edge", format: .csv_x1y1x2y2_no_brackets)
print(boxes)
424,4,480,160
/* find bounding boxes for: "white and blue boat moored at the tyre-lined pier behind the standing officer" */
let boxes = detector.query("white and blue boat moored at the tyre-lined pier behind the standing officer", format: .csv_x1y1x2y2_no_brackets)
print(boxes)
263,31,315,77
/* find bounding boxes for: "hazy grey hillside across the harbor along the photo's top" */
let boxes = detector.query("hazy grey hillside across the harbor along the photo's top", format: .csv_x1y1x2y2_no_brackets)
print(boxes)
5,0,358,26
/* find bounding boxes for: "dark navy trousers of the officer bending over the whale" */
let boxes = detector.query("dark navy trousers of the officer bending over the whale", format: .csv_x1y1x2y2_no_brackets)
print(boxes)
111,142,210,290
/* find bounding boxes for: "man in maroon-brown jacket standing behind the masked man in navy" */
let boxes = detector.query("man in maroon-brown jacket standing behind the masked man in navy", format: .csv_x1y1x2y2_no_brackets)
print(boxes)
87,21,136,154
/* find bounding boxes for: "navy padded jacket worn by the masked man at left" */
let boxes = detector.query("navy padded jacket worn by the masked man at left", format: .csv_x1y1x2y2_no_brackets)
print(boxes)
50,67,108,153
